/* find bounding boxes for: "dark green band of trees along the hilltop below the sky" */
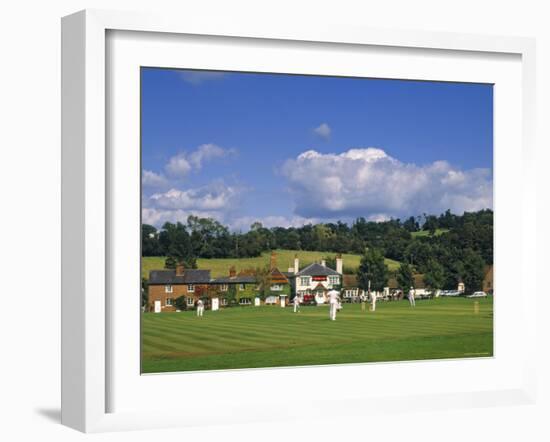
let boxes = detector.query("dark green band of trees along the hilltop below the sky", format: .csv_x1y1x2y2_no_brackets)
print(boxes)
142,210,493,290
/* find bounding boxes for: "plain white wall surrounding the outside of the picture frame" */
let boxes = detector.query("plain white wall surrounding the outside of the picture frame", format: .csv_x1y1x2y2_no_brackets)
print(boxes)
0,0,550,442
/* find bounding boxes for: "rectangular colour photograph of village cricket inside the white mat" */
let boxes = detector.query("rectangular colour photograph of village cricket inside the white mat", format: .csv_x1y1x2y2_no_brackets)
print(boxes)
141,66,495,374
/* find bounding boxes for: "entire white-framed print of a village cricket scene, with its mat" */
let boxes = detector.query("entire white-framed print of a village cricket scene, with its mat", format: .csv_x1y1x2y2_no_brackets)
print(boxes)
62,11,535,431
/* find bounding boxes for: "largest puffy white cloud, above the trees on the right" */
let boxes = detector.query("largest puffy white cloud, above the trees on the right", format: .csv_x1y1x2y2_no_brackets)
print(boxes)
282,147,493,220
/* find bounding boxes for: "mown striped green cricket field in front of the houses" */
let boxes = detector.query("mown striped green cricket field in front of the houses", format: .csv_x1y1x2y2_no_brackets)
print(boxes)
141,297,493,373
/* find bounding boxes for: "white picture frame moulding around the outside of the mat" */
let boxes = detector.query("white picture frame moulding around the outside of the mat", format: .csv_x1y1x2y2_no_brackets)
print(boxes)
62,10,536,432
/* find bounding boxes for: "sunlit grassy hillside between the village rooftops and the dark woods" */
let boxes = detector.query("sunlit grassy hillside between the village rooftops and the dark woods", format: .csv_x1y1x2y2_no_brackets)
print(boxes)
141,250,399,278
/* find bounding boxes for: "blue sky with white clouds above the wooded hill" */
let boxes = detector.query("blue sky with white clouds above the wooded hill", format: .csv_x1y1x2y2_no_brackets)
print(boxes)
141,68,493,230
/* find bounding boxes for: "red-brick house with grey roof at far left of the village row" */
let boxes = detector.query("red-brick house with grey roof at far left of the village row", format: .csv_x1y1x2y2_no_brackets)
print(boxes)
147,264,210,313
